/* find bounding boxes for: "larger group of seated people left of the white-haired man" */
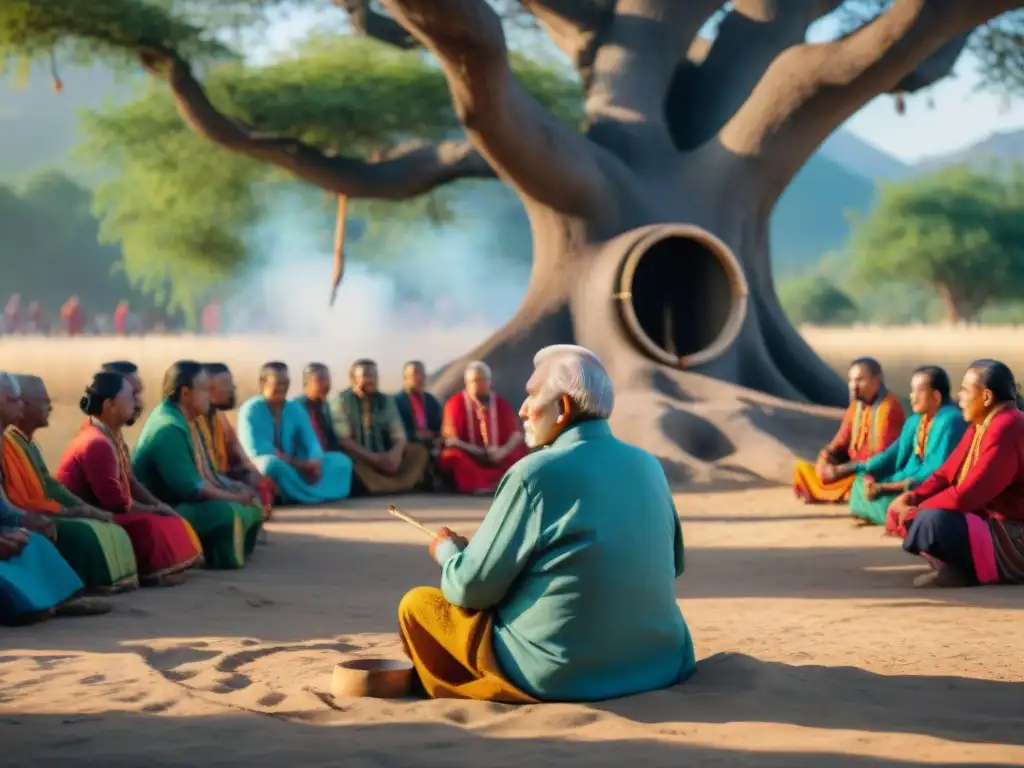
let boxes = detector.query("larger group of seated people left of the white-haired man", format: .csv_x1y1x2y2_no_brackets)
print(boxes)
0,359,526,623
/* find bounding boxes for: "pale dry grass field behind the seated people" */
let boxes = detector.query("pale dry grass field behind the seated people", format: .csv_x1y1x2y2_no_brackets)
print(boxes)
0,327,1024,460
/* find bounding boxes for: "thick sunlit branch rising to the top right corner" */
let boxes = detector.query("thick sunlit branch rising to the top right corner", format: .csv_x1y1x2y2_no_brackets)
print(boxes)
720,0,1024,205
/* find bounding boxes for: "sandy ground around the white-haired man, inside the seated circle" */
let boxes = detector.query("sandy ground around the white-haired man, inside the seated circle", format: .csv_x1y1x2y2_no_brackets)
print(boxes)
0,489,1024,768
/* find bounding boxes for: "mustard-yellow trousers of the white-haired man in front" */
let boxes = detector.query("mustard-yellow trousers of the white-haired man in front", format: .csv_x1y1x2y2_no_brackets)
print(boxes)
398,587,538,703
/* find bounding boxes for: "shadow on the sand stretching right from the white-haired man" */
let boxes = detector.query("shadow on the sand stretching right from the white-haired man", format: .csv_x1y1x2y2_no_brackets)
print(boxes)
595,653,1024,749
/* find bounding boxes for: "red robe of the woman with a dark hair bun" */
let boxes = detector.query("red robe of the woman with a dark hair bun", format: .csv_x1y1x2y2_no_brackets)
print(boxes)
56,420,203,584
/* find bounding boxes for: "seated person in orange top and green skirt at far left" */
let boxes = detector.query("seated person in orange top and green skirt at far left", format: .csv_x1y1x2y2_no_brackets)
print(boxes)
0,376,138,592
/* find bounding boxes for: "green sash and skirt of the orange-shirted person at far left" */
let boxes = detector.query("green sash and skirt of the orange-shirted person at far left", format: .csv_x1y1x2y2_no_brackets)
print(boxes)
7,429,138,592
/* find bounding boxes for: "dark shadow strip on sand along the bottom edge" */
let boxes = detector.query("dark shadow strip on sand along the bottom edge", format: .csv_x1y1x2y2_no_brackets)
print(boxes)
0,712,1011,768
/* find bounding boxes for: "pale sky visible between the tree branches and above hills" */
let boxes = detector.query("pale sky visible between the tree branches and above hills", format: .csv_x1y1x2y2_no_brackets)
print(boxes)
266,5,1024,163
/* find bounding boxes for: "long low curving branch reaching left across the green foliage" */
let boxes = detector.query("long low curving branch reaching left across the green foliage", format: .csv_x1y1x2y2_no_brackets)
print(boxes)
139,48,494,200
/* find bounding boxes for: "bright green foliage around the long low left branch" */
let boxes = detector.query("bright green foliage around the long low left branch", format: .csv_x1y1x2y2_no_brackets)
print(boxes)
72,35,581,312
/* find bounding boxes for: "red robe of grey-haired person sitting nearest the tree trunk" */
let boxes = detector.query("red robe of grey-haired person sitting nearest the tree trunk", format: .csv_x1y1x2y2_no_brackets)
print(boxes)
437,390,527,494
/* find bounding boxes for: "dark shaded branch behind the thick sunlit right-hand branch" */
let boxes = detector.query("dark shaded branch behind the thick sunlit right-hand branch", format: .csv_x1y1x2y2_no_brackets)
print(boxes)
667,0,843,151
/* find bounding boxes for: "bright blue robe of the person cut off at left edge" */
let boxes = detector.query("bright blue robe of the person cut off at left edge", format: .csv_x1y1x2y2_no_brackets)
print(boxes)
0,499,85,623
